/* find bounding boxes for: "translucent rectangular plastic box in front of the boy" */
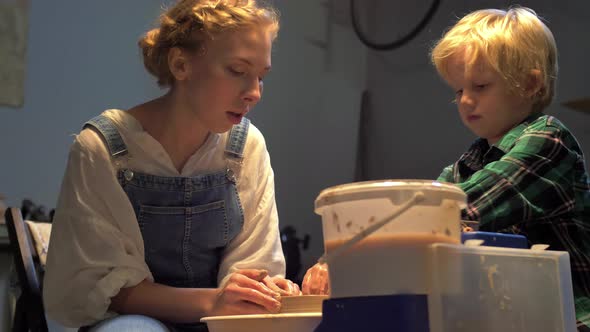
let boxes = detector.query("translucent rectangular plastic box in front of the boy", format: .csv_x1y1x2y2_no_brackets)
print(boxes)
428,244,576,332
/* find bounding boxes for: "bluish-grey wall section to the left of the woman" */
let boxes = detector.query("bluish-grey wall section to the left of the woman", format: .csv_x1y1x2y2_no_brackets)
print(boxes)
0,0,161,207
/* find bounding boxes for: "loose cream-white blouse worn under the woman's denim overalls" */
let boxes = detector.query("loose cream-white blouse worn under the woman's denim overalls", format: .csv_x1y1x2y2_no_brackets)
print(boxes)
43,110,285,327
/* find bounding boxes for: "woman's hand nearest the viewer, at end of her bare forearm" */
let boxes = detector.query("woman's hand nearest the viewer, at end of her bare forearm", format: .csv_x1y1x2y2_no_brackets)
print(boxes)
211,269,281,316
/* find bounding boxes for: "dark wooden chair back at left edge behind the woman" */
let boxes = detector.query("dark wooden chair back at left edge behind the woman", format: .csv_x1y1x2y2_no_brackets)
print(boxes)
4,207,48,332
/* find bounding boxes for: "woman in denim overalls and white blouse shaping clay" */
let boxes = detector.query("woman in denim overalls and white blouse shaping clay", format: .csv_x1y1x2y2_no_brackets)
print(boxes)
43,0,300,331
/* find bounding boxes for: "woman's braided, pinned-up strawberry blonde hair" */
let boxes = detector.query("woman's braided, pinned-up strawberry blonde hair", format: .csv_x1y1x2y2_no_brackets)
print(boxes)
138,0,279,87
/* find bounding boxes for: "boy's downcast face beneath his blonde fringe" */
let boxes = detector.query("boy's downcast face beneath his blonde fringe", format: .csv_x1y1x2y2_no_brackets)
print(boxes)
447,52,533,145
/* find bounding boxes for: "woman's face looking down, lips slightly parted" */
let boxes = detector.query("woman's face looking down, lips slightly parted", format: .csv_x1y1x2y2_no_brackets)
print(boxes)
175,27,272,133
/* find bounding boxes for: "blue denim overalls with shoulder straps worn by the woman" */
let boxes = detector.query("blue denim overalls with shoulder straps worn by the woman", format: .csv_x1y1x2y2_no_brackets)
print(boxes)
85,115,250,331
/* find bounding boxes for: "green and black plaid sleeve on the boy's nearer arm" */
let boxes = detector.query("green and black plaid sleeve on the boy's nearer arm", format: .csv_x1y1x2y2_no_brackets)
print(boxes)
456,126,580,231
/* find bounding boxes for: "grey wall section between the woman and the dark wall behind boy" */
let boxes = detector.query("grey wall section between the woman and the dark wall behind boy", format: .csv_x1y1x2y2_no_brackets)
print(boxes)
262,0,365,272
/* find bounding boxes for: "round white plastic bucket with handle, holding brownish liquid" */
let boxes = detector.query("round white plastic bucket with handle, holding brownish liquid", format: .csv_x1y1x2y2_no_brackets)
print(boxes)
315,180,466,298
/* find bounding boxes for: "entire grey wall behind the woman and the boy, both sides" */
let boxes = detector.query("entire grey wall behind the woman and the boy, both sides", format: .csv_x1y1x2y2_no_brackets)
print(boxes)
0,0,590,304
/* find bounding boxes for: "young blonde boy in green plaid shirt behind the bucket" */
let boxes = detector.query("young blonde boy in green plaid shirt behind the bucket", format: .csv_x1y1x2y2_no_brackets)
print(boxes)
431,7,590,328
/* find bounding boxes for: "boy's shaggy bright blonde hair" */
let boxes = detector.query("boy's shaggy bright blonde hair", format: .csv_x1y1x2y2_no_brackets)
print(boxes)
431,7,558,111
